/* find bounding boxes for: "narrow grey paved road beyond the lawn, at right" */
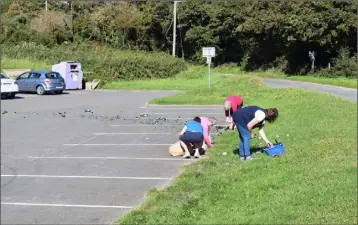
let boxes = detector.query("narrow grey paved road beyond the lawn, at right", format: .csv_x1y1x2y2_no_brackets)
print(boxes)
261,78,357,102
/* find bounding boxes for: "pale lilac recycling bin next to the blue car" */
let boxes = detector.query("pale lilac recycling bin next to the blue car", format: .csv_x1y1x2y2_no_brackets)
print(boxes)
52,61,83,90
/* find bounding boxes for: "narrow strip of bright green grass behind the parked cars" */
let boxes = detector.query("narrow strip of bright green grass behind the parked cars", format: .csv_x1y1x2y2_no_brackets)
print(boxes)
1,58,51,70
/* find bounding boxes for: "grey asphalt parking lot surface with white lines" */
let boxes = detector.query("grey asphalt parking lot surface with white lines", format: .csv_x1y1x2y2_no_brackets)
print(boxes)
1,90,225,224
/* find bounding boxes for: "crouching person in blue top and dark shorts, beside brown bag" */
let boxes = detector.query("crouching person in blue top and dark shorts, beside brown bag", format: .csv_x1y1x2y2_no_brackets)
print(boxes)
179,117,204,158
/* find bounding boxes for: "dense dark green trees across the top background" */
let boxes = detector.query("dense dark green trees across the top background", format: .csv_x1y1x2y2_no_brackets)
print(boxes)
1,0,357,76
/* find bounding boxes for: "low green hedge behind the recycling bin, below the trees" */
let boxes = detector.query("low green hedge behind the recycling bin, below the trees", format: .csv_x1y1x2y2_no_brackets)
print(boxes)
2,43,187,83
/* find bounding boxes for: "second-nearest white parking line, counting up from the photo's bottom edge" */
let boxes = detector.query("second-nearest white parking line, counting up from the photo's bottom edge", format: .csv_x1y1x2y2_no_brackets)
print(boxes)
1,174,171,180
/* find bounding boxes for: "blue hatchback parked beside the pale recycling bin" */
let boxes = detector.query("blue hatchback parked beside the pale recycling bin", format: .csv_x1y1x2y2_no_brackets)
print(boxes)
16,70,66,95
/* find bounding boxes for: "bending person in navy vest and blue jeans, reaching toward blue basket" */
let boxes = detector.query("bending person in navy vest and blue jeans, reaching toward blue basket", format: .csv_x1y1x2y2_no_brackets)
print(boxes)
233,106,278,160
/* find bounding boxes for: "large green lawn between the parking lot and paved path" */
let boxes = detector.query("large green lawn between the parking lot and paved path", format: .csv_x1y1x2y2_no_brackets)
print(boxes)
116,66,357,224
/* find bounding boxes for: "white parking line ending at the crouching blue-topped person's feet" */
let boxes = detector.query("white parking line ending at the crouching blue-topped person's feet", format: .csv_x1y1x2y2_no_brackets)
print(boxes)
27,156,190,161
